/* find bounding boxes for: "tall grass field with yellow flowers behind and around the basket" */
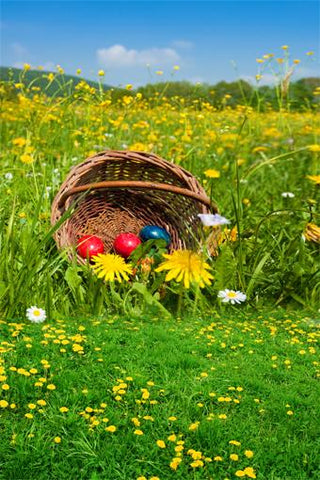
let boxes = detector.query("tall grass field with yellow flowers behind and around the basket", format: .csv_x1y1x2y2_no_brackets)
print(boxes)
0,67,320,318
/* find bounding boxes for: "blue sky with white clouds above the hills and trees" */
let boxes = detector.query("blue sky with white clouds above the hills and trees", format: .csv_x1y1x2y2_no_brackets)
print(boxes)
1,0,320,85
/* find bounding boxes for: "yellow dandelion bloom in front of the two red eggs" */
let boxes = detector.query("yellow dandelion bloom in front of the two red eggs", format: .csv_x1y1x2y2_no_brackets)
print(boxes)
92,253,132,282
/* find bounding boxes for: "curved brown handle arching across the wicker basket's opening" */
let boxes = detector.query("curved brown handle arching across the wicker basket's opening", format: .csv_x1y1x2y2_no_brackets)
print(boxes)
58,180,218,212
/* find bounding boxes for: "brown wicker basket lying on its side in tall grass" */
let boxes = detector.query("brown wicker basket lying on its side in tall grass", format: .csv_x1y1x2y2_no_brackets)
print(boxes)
51,150,217,263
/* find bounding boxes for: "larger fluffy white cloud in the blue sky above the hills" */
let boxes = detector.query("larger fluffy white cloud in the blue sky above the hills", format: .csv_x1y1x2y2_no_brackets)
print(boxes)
97,45,180,68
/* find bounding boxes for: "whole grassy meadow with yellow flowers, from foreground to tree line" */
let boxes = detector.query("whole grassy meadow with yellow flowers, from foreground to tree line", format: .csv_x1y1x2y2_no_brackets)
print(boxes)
0,61,320,480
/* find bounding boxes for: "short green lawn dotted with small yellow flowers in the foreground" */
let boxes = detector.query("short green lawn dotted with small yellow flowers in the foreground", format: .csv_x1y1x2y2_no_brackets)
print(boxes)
0,309,320,480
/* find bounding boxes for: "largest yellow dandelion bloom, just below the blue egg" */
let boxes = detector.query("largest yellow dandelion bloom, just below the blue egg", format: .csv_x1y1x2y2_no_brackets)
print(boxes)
156,250,213,288
